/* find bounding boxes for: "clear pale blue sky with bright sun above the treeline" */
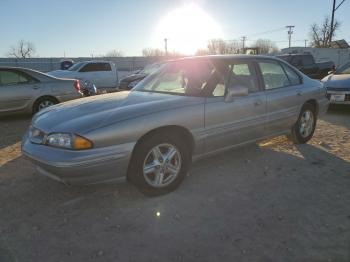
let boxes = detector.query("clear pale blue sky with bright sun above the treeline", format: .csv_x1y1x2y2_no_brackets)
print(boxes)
0,0,350,57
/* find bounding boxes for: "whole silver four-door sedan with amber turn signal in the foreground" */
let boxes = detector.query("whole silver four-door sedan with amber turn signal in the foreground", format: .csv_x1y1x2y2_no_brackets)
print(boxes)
22,55,329,195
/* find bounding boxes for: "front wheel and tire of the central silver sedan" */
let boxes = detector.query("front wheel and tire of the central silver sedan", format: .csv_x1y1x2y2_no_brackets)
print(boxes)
128,132,191,196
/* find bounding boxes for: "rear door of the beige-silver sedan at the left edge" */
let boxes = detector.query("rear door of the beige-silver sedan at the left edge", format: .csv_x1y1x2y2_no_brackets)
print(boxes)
0,69,40,112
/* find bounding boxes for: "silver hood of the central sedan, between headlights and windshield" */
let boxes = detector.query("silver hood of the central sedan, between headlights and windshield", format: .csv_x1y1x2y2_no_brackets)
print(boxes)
32,91,204,135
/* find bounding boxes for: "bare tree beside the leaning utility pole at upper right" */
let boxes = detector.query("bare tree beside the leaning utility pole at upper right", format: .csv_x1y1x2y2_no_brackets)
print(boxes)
310,17,340,47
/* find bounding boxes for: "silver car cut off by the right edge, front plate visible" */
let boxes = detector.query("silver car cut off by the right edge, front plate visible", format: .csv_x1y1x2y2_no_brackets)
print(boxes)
322,62,350,105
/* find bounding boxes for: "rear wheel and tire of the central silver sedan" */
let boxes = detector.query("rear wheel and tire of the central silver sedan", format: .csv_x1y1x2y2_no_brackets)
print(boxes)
289,103,317,144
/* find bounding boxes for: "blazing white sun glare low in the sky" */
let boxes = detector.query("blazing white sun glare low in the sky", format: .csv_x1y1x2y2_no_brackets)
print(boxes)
154,4,223,55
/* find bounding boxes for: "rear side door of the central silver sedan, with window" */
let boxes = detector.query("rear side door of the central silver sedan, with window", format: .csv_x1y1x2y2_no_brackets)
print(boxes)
258,59,303,135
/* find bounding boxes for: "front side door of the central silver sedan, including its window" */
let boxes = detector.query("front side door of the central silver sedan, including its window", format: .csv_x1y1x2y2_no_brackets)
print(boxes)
205,60,266,153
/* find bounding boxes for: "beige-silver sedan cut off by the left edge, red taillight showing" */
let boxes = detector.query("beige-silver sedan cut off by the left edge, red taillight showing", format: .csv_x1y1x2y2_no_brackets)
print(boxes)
0,67,82,115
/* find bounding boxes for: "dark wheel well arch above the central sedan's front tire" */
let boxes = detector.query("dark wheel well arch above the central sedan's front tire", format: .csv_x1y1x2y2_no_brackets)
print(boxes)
127,125,195,179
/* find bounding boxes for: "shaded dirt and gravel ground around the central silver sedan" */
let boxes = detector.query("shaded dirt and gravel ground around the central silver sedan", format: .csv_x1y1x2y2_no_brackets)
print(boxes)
0,107,350,262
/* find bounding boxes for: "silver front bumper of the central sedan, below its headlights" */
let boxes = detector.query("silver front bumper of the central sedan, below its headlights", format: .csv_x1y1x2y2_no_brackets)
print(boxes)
22,133,135,185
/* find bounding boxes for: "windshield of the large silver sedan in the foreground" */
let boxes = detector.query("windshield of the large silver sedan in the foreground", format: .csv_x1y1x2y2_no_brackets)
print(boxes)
134,60,219,96
